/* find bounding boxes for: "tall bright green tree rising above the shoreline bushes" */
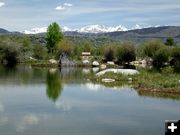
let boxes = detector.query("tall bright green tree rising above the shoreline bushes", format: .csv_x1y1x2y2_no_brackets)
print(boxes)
46,22,63,54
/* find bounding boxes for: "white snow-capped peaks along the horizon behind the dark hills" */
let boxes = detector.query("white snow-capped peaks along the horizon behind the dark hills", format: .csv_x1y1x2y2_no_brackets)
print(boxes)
23,25,150,34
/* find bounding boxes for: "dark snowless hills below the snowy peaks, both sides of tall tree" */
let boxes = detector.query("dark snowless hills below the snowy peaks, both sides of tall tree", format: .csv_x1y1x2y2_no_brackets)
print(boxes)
0,26,180,45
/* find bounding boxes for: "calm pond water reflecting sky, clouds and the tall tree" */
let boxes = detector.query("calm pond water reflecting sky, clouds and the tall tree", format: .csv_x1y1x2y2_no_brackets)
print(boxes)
0,66,180,135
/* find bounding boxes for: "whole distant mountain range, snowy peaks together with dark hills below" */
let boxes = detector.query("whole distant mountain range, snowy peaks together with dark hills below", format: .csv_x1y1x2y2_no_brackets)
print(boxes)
0,25,180,44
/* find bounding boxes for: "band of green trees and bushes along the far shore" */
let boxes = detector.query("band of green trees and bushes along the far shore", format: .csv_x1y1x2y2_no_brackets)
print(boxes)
0,22,180,67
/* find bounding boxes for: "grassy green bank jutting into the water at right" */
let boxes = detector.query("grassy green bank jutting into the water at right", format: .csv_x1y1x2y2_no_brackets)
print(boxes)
91,70,180,93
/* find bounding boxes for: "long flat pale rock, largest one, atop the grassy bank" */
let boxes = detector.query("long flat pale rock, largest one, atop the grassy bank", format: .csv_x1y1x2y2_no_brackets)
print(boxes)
96,69,139,76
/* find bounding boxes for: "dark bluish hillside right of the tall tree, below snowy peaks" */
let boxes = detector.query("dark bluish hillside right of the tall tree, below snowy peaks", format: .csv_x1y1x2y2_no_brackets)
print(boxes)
65,26,180,43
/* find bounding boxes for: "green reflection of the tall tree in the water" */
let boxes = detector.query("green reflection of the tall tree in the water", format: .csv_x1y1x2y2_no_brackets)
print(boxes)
46,69,63,102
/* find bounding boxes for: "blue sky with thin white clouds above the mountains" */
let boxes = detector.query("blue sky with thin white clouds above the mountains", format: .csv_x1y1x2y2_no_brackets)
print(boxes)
0,0,180,31
